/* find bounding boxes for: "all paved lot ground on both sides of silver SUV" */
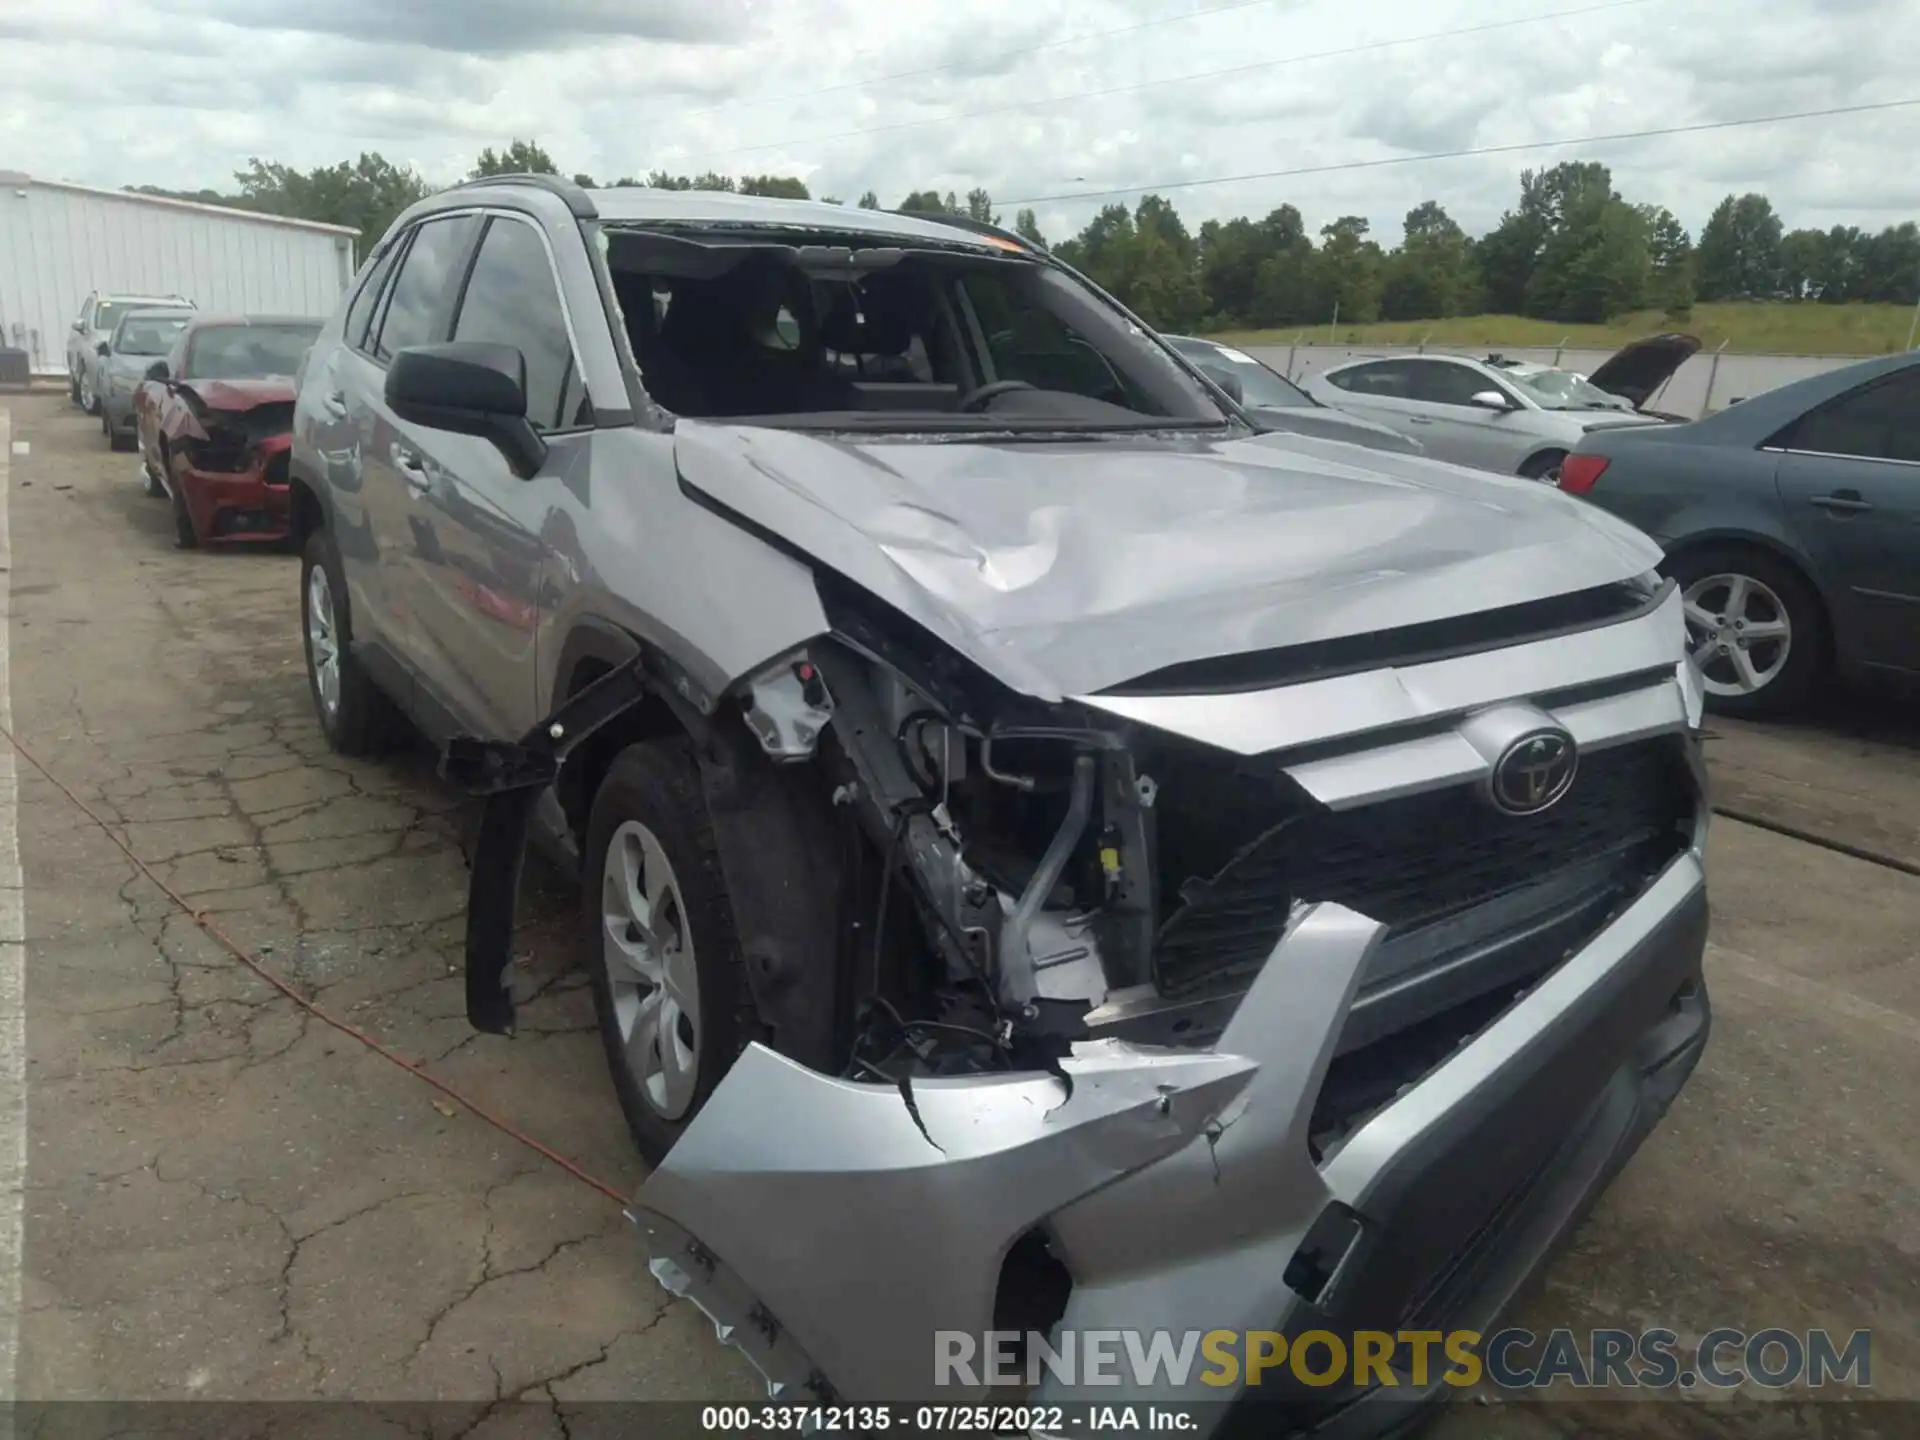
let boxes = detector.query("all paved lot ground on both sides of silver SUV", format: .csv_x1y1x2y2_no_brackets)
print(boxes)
0,396,1920,1436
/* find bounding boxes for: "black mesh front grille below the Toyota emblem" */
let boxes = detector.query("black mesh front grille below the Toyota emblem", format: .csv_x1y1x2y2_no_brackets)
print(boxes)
1154,737,1693,995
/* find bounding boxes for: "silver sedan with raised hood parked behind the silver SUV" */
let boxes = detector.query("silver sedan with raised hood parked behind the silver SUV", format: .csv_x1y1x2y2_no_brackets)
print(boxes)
1306,336,1697,482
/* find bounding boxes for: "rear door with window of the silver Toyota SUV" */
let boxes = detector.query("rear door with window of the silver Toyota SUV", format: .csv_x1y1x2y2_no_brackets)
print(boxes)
336,211,480,706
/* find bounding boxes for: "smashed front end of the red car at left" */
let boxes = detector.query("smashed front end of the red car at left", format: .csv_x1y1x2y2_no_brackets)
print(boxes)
169,386,294,541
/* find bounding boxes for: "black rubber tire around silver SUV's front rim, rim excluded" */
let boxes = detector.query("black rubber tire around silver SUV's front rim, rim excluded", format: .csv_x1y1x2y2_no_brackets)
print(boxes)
580,739,758,1165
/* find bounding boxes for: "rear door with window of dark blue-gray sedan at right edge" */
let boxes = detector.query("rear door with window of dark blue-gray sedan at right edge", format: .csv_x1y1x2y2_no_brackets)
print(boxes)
1768,365,1920,670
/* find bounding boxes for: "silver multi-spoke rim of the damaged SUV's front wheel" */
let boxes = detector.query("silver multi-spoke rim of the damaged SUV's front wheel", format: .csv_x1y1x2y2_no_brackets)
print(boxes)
601,820,701,1119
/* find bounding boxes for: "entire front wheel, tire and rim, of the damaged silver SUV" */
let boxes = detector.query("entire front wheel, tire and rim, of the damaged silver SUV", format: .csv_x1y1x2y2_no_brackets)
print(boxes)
582,739,756,1165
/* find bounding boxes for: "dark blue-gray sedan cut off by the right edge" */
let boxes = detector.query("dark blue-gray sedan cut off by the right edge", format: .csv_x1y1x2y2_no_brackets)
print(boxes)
1559,351,1920,714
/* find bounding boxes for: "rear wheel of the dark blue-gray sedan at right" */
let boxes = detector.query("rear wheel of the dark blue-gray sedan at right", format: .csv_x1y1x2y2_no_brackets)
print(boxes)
1668,545,1828,716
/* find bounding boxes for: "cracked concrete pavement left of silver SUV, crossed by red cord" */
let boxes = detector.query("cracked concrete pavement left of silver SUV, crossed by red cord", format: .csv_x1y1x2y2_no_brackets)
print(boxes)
10,397,760,1432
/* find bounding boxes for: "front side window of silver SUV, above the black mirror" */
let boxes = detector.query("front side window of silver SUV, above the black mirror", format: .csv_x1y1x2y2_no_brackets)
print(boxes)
453,217,588,430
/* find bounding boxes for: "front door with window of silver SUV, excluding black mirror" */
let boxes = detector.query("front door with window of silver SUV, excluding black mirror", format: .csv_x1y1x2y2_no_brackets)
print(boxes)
399,211,593,739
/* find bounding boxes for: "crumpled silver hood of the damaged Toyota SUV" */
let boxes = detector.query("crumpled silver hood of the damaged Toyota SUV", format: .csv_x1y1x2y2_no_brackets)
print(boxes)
674,420,1661,699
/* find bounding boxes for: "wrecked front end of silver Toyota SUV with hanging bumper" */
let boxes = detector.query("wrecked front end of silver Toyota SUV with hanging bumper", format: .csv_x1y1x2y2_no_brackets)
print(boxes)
449,580,1707,1432
